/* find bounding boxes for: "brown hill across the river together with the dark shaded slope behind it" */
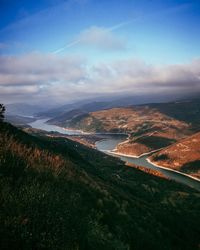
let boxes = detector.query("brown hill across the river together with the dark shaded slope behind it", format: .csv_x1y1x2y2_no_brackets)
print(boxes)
45,99,200,156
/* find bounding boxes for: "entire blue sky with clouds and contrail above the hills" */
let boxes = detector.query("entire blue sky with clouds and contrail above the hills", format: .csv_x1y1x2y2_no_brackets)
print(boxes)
0,0,200,104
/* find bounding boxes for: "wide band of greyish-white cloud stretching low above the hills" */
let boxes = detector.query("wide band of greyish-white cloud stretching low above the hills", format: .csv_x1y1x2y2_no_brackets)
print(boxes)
0,52,200,102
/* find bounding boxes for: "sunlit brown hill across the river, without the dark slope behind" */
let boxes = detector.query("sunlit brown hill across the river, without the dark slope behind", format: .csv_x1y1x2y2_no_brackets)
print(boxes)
49,106,191,156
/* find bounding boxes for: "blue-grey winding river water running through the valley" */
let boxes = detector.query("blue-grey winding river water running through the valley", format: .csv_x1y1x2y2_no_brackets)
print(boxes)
29,119,200,191
